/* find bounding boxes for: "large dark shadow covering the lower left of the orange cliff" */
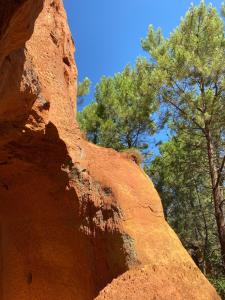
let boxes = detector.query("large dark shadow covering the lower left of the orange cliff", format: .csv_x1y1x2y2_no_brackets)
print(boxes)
0,124,137,300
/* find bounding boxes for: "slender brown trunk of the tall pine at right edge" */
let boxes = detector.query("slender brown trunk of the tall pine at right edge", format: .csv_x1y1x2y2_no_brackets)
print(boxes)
205,128,225,269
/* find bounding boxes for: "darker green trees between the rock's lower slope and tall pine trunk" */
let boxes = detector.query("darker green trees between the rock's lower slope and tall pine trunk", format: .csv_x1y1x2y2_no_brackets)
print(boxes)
145,131,221,273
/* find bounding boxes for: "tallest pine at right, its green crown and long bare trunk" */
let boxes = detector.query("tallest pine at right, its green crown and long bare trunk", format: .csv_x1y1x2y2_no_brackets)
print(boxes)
142,1,225,266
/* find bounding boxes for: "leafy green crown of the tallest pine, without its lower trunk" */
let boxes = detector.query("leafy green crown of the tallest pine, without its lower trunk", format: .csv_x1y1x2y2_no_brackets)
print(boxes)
142,2,225,135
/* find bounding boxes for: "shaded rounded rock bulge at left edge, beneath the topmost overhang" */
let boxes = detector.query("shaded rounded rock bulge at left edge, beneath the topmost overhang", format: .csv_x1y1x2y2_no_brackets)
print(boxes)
0,49,41,129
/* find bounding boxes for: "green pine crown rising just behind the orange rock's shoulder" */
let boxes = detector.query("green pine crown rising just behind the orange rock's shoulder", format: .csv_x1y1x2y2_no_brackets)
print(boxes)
78,59,158,150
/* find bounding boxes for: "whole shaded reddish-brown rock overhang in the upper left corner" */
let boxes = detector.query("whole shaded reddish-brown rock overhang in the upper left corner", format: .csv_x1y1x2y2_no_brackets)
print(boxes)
0,0,44,143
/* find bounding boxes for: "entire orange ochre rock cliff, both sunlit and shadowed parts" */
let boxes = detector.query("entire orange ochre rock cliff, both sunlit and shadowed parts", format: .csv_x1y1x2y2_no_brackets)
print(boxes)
0,0,219,300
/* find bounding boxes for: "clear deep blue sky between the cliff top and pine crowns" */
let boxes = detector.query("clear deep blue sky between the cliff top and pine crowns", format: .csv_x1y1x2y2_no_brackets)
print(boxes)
64,0,222,110
